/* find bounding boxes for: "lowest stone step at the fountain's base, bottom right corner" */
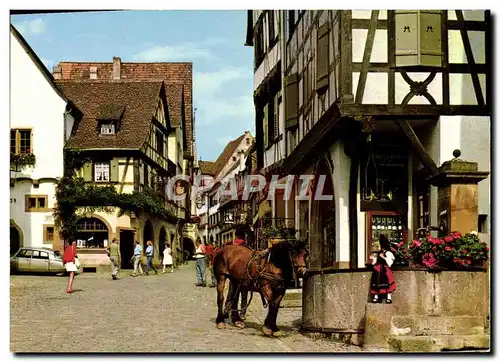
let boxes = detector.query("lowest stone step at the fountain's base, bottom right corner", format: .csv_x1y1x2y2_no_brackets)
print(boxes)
388,334,490,353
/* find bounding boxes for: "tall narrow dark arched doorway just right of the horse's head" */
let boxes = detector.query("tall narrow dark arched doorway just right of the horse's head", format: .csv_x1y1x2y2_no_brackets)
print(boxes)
311,158,336,267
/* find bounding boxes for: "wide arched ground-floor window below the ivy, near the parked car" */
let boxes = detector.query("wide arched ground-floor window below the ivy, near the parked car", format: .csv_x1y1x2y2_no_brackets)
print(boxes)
76,217,111,248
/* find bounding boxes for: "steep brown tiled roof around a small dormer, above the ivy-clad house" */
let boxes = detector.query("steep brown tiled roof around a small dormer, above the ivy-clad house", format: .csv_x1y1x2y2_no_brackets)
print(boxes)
57,80,164,149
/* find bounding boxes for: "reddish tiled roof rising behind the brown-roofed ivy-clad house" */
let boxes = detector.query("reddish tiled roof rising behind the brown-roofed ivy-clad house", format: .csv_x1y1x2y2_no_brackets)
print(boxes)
58,62,194,155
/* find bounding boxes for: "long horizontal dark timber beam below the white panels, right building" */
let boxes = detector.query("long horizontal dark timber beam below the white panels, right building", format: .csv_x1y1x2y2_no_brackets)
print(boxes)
339,104,491,119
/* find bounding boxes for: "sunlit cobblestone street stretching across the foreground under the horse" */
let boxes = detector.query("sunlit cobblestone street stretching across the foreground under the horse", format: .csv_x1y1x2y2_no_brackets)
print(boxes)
10,262,360,352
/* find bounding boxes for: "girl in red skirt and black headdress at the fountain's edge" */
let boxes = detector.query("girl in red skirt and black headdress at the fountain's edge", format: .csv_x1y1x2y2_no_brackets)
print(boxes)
370,234,396,303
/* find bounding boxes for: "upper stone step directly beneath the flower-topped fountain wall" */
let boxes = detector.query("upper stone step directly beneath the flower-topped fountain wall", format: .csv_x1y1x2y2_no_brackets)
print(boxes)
390,316,486,336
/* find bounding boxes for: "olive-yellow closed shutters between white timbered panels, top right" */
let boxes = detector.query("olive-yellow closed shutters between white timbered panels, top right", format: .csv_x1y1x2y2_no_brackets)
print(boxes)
394,10,443,68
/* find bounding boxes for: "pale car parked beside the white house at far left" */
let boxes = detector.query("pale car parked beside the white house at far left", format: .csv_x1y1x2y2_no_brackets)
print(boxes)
10,247,66,274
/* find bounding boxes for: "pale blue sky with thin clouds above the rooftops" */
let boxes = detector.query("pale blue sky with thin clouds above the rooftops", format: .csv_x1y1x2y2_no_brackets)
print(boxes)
11,10,255,160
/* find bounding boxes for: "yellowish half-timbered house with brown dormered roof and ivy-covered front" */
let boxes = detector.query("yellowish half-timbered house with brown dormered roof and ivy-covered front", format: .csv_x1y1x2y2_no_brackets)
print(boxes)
57,80,186,267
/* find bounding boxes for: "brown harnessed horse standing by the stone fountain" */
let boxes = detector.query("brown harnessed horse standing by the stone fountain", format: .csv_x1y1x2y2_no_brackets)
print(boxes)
214,241,308,337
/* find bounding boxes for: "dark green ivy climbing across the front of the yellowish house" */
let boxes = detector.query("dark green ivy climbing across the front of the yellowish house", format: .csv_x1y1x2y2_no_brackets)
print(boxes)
54,151,177,240
